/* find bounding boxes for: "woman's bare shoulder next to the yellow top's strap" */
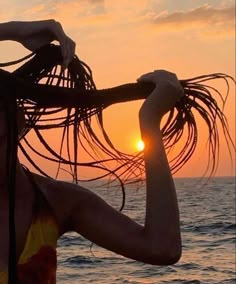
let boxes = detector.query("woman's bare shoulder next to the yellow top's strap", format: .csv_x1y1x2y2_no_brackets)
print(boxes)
30,174,93,233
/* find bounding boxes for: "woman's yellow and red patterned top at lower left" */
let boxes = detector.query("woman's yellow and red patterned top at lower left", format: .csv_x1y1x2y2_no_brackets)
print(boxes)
0,172,59,284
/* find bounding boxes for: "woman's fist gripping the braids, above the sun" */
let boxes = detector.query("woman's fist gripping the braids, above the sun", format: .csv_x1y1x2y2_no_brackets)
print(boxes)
137,70,184,126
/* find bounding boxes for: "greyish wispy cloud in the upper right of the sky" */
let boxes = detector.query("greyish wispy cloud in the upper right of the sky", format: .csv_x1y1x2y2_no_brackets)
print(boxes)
146,4,235,36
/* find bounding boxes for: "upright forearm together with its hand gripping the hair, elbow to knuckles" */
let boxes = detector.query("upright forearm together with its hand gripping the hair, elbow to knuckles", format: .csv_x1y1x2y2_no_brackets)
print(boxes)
139,70,184,260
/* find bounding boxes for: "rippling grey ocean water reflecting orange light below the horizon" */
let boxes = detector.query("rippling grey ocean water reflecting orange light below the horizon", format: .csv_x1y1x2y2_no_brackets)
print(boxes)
57,177,236,284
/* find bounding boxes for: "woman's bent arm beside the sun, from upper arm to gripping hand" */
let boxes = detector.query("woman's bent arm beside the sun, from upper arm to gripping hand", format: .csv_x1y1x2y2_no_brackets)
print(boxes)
49,71,182,265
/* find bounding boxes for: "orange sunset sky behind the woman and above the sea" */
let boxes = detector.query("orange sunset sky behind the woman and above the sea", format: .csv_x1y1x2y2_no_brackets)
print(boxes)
0,0,235,177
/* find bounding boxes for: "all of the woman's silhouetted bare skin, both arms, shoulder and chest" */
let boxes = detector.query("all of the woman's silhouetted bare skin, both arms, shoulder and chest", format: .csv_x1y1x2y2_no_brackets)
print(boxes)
0,20,183,271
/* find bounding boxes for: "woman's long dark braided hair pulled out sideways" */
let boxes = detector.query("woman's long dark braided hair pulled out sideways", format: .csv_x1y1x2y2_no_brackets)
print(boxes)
0,44,235,283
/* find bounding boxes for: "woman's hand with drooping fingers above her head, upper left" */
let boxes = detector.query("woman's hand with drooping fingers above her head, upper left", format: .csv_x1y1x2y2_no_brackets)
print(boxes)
12,20,75,68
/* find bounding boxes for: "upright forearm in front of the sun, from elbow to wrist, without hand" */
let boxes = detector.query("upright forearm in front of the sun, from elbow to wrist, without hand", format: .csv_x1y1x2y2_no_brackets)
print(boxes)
140,120,181,258
